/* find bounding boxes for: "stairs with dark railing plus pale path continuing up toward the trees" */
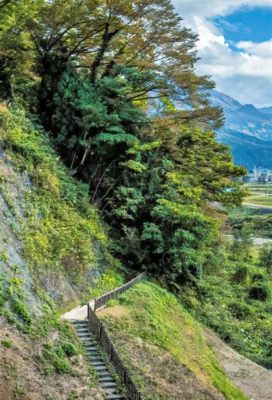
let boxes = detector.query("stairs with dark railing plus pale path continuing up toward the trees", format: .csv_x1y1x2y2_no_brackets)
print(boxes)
61,272,145,400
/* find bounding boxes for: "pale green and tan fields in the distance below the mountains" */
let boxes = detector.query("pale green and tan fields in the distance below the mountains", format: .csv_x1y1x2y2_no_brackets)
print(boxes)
244,183,272,207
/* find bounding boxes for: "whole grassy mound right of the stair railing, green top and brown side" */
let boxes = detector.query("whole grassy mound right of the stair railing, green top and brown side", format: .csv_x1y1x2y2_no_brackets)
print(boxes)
100,283,246,400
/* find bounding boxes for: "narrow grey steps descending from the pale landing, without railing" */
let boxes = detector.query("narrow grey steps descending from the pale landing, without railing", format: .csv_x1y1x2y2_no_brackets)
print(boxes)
71,320,125,400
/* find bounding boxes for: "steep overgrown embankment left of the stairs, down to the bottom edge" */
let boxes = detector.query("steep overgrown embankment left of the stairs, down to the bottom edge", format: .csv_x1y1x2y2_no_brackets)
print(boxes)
0,106,110,400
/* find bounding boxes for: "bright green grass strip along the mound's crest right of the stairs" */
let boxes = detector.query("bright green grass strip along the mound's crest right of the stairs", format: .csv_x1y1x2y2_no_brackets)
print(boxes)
100,282,249,400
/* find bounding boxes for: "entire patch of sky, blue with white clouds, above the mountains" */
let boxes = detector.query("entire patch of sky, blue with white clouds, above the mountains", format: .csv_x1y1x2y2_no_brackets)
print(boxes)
173,0,272,107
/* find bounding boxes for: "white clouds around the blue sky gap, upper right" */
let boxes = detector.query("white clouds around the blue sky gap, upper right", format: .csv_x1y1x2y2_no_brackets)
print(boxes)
173,0,272,107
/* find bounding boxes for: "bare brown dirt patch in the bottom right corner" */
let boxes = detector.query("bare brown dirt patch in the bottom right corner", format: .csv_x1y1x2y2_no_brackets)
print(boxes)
206,330,272,400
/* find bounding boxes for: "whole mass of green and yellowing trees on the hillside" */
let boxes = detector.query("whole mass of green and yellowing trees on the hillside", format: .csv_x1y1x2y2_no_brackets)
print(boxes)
0,0,243,285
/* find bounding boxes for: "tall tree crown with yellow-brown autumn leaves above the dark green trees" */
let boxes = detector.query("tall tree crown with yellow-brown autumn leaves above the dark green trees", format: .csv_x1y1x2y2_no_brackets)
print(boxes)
25,0,221,128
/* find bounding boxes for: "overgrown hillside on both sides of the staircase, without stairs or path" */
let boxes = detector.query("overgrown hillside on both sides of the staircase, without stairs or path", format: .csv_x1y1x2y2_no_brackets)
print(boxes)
0,107,249,400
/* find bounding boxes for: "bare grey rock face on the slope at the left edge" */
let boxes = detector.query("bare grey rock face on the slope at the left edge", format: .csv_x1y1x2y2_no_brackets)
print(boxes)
0,143,41,314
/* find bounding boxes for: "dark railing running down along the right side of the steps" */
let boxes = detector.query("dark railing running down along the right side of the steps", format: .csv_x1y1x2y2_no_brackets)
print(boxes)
88,304,142,400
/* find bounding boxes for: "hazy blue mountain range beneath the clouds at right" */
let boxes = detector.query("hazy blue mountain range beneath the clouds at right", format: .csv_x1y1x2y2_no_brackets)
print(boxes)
211,90,272,170
